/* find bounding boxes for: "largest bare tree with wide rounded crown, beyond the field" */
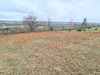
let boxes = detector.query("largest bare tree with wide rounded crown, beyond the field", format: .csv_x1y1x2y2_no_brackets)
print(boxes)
23,13,38,32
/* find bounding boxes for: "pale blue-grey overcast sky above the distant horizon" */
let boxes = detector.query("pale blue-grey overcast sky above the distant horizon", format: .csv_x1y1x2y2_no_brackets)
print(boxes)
0,0,100,23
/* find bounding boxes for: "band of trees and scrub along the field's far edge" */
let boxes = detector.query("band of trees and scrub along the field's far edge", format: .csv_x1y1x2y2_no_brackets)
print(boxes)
0,13,97,34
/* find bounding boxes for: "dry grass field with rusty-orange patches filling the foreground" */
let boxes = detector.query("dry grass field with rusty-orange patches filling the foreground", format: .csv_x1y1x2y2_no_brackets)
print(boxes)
0,31,100,75
